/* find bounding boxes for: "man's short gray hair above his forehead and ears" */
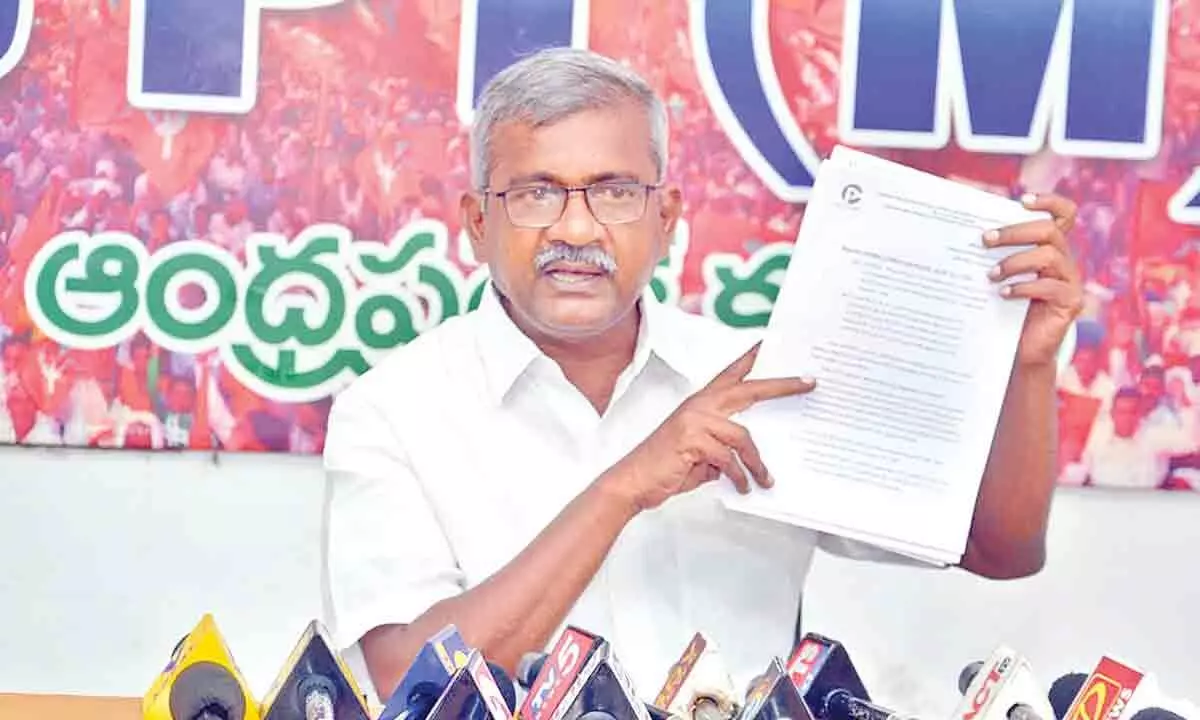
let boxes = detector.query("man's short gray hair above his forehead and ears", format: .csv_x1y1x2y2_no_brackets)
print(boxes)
470,48,667,190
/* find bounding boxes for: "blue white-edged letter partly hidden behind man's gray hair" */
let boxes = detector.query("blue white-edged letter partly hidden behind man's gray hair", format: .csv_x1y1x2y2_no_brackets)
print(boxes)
455,0,590,125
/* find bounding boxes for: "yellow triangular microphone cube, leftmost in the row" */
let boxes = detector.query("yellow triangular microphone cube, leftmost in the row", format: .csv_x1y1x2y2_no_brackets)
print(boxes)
142,613,259,720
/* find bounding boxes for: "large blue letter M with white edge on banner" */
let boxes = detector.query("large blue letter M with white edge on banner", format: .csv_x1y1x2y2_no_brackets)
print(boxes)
839,0,1170,160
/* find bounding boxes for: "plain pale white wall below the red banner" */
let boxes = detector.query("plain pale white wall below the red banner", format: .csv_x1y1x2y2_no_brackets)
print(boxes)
0,448,1200,718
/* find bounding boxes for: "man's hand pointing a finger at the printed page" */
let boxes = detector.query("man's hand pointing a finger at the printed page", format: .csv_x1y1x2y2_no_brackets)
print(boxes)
605,344,815,511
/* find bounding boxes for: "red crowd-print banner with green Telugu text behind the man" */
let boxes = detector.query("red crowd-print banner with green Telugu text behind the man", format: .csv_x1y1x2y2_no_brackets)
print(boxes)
0,0,1200,490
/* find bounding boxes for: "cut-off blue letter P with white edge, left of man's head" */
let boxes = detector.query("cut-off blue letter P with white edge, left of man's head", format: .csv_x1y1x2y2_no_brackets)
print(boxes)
127,0,341,114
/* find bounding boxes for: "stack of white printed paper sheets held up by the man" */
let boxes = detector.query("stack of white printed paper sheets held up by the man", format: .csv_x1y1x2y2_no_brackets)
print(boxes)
725,148,1045,564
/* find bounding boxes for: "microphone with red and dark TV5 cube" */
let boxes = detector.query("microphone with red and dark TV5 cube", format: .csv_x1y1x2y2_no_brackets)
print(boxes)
517,625,650,720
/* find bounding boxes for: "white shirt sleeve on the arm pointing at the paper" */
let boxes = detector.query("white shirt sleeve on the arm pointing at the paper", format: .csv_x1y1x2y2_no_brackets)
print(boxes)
324,382,464,648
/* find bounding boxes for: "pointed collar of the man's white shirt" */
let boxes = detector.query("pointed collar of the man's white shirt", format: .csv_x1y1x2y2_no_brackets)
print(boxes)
475,283,712,404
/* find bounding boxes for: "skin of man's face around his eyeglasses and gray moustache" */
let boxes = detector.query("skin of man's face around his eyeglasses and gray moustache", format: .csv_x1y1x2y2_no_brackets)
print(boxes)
463,103,680,338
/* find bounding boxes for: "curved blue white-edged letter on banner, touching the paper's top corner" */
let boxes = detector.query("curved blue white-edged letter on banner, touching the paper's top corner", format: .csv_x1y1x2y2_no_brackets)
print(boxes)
689,0,820,203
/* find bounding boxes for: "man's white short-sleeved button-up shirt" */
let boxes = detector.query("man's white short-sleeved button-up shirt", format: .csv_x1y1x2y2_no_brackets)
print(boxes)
325,292,902,700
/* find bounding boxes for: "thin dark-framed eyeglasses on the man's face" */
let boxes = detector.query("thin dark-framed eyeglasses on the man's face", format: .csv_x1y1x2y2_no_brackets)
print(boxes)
484,181,660,229
